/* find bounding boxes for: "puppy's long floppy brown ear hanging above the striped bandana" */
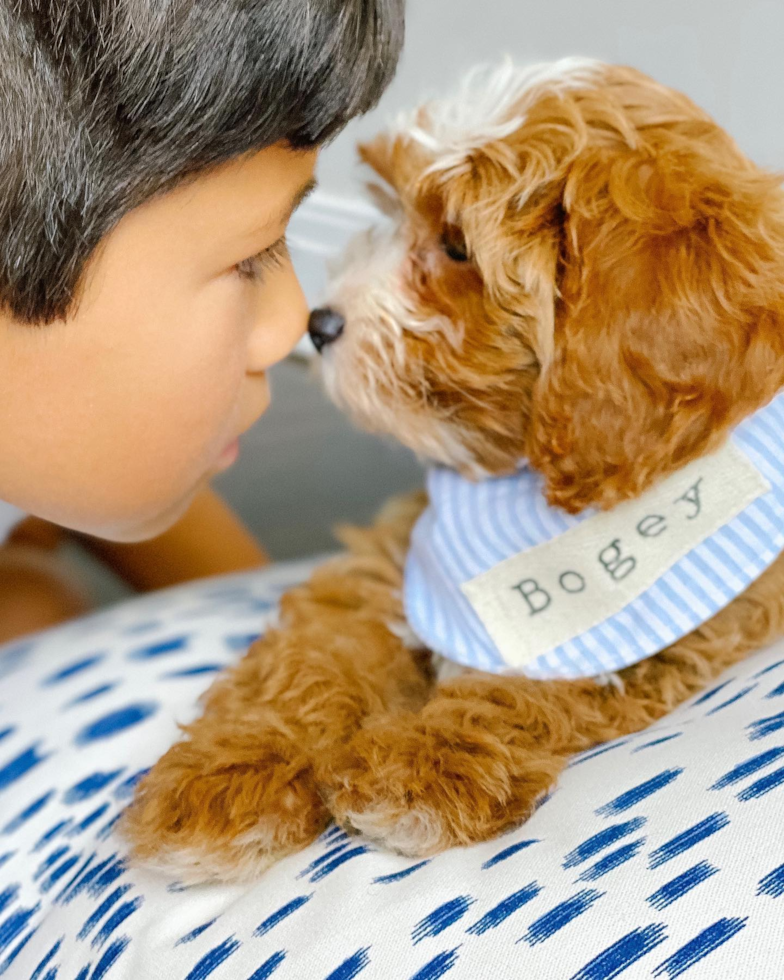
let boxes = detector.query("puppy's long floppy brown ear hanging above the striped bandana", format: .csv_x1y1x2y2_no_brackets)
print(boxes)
527,138,784,512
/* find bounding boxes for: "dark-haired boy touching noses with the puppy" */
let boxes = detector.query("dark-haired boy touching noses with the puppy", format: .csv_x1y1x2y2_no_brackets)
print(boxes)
0,0,404,632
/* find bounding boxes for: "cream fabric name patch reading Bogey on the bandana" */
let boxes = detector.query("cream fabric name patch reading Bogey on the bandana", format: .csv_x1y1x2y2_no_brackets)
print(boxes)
461,443,771,667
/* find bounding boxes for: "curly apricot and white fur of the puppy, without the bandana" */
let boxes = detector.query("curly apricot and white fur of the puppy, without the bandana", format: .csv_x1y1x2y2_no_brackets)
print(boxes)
125,66,784,880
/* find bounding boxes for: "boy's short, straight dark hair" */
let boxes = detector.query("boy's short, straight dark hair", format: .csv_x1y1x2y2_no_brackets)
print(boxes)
0,0,404,323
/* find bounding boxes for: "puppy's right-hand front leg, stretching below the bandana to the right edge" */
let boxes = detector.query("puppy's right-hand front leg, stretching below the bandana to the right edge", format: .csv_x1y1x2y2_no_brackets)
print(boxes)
320,559,784,856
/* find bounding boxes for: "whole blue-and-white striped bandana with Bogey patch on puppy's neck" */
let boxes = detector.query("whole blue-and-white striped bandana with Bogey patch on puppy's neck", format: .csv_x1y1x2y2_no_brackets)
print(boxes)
404,392,784,680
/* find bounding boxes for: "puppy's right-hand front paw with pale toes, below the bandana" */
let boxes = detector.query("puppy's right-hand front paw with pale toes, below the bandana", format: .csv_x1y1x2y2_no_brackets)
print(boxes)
319,718,564,857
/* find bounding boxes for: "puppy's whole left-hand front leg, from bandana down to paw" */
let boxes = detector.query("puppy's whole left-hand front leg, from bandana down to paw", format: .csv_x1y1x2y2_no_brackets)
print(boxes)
124,494,431,881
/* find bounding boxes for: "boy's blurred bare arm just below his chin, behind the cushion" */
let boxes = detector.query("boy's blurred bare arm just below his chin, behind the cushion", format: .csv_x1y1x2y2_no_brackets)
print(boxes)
80,489,269,592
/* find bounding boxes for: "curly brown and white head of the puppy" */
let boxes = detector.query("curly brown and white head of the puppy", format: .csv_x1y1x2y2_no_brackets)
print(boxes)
312,60,784,511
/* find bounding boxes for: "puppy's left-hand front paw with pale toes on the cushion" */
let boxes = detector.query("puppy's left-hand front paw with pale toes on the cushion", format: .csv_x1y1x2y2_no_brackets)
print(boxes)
121,730,329,884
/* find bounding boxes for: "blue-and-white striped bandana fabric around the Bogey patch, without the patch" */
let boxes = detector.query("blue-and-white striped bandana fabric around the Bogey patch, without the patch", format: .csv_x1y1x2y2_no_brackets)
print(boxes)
405,393,784,679
